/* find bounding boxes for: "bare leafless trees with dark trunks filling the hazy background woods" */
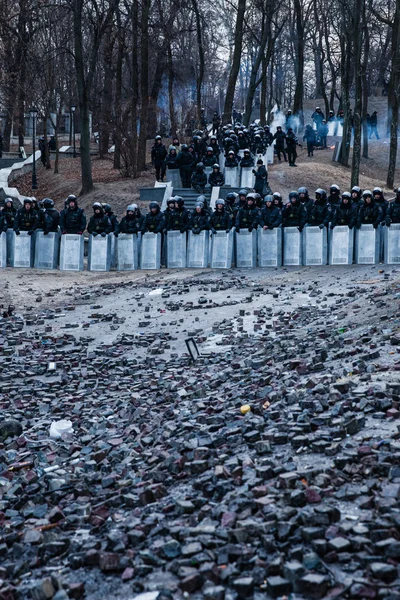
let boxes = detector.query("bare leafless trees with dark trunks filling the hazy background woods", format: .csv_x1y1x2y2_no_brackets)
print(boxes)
0,0,400,193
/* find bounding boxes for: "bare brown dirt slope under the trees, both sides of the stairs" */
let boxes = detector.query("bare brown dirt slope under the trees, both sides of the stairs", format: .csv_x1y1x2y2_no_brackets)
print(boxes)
10,97,398,217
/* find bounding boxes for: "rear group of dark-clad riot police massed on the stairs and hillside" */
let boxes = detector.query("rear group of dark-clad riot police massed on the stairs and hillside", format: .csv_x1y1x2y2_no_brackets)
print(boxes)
151,106,379,186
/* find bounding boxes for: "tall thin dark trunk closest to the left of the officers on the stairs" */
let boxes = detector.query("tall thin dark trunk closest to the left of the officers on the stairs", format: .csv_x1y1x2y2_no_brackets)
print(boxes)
138,0,150,171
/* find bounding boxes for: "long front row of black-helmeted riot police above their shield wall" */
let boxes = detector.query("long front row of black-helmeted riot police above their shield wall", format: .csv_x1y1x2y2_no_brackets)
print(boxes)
0,184,400,237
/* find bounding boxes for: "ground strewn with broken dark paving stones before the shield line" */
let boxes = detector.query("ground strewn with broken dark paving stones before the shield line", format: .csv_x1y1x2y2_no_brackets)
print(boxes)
0,265,400,600
